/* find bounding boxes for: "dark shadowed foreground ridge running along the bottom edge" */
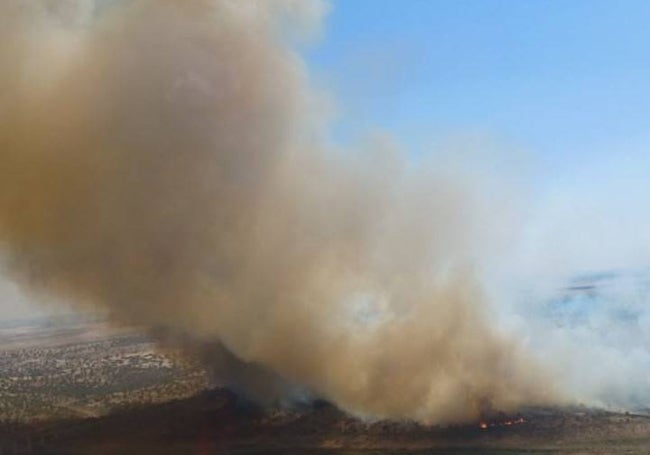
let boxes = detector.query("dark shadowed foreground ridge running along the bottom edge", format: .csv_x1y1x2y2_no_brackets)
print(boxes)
0,389,650,455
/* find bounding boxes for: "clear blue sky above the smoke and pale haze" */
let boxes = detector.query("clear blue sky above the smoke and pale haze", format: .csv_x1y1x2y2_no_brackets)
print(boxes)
309,0,650,173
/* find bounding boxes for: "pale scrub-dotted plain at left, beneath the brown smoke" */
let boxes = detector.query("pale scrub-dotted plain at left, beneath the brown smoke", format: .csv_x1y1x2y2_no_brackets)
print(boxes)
0,321,207,422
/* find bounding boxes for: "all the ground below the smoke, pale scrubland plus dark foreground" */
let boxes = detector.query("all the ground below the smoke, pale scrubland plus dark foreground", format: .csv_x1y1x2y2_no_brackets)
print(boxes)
0,321,650,455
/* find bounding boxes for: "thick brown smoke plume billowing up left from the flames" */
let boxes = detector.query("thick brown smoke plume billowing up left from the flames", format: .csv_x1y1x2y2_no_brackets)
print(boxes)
0,0,549,422
